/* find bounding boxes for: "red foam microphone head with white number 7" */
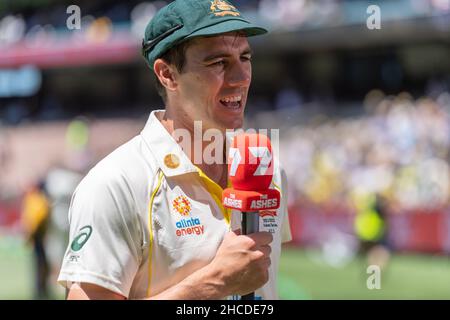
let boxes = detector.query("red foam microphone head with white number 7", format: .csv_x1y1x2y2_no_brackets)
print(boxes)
228,133,273,191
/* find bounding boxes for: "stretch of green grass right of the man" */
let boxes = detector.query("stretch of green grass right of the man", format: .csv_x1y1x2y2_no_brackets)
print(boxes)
280,248,450,300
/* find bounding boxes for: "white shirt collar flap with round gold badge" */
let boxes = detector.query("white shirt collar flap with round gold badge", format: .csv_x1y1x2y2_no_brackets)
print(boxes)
141,110,198,177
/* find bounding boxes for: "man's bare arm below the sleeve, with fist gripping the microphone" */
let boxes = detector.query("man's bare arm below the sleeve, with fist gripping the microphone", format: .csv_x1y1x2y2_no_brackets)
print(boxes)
68,232,273,300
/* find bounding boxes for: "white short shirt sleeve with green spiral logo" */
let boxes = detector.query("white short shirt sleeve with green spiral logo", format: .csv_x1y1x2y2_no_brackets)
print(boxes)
58,162,142,297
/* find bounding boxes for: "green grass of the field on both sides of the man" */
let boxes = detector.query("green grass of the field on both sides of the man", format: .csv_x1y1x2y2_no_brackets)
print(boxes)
0,237,450,300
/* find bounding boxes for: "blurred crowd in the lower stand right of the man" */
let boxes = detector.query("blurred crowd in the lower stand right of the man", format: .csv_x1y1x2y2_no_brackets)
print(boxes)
280,90,450,212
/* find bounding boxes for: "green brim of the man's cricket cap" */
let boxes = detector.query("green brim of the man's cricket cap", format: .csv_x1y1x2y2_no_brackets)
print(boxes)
185,19,268,39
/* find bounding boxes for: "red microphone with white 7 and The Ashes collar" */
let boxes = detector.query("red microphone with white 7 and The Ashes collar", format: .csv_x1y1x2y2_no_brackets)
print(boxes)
222,133,280,300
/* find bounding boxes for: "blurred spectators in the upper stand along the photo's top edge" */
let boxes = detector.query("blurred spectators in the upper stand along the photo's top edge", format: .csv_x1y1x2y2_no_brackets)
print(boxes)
0,0,450,47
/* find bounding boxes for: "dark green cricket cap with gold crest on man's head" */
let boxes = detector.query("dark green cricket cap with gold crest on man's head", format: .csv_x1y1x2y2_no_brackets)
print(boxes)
142,0,267,70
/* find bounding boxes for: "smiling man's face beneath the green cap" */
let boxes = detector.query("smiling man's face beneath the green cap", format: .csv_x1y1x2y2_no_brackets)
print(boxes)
172,33,252,130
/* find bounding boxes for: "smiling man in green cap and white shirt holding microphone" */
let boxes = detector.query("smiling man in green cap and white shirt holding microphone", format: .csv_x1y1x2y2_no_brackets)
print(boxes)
59,0,290,299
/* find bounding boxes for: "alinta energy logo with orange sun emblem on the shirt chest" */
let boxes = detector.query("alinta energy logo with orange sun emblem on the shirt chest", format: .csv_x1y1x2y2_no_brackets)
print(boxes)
172,195,205,237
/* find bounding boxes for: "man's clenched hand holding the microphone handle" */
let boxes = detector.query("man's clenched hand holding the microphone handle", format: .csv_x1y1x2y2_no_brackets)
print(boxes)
208,232,273,295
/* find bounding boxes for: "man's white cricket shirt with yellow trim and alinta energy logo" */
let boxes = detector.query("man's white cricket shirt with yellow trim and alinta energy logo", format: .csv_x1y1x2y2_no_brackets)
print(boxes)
58,110,291,299
